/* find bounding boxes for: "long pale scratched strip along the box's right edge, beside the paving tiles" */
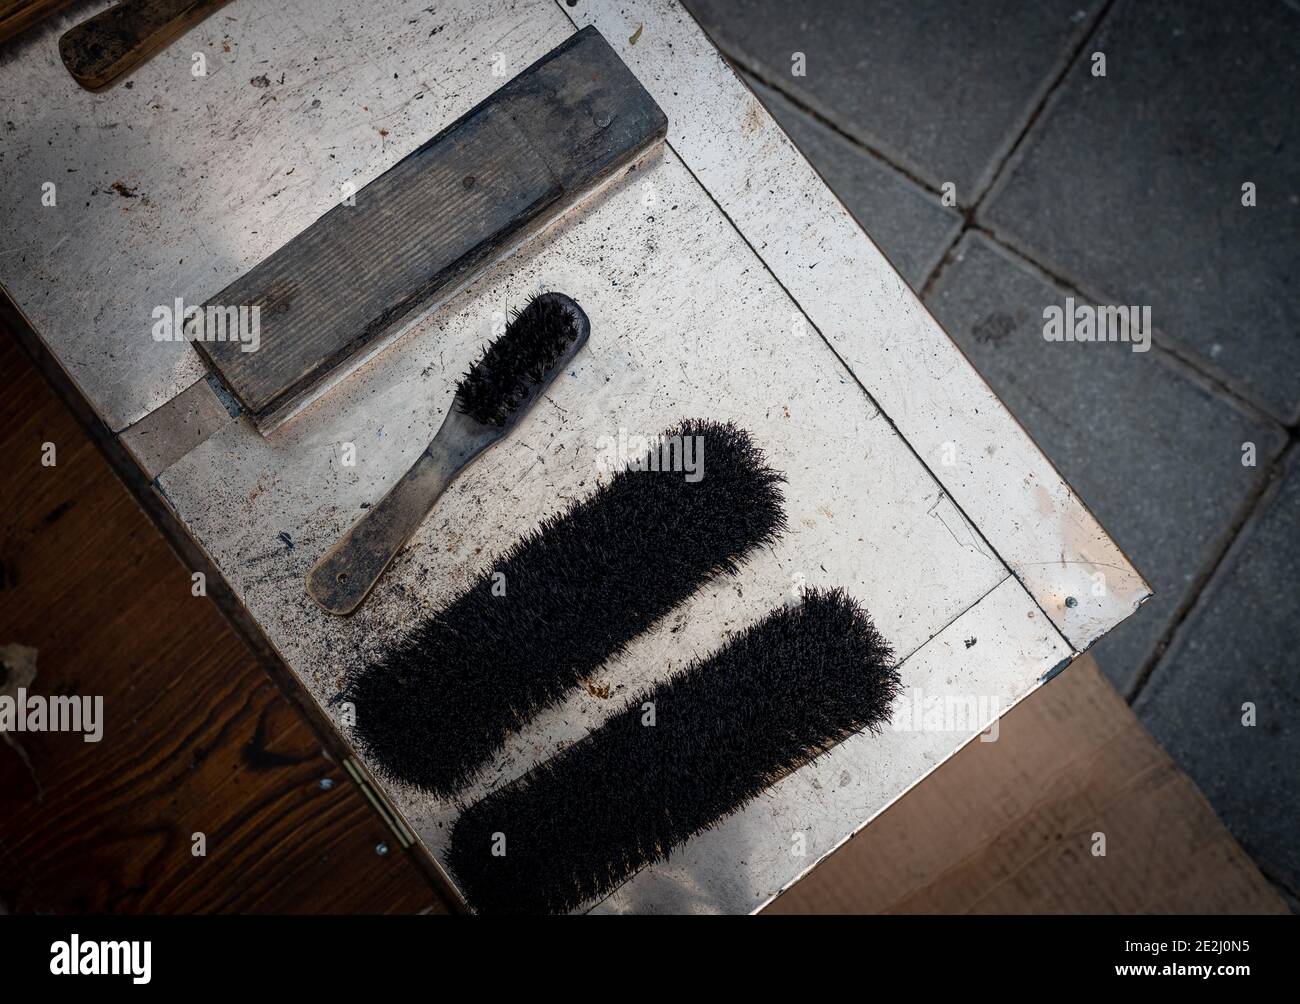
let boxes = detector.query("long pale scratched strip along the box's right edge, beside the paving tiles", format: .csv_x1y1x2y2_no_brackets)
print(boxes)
562,0,1151,650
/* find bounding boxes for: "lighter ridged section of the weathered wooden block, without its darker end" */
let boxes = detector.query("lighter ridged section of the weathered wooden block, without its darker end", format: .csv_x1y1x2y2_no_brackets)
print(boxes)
200,108,560,416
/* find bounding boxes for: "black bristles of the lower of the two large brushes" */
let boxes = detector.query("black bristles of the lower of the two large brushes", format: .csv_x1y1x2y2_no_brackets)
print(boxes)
447,589,901,913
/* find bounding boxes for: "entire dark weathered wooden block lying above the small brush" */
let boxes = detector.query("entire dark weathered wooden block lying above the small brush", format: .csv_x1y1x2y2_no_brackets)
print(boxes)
198,29,667,432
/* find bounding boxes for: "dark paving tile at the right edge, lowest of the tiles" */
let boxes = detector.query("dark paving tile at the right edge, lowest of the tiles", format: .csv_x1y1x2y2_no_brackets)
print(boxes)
1134,449,1300,904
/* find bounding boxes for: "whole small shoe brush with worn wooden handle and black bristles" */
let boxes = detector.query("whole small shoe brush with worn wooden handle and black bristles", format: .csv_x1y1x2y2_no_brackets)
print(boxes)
307,293,590,615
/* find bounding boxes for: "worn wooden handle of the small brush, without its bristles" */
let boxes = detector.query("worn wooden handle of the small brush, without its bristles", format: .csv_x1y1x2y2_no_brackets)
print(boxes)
307,438,468,616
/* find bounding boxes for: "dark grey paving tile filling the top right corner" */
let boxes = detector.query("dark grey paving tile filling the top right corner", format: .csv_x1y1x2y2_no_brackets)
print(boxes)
980,0,1300,423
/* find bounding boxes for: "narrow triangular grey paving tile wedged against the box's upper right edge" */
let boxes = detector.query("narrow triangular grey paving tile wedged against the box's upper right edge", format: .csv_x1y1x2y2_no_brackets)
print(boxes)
748,78,962,289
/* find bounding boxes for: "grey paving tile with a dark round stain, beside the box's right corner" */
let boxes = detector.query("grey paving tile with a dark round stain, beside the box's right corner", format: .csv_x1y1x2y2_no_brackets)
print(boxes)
927,233,1284,693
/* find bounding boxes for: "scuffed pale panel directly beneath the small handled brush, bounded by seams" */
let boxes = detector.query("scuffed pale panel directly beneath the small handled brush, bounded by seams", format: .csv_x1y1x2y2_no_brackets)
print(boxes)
160,145,1013,905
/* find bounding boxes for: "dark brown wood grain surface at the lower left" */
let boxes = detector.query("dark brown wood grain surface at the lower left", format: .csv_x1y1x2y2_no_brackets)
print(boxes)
0,332,443,913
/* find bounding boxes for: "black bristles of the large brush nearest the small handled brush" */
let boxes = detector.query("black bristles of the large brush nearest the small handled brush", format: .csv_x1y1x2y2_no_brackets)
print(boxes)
347,420,785,797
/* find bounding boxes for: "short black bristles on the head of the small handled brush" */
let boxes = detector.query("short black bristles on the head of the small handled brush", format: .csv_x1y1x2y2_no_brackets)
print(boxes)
456,295,579,427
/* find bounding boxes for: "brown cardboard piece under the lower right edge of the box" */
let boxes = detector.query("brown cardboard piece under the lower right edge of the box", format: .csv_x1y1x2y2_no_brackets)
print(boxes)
764,655,1287,914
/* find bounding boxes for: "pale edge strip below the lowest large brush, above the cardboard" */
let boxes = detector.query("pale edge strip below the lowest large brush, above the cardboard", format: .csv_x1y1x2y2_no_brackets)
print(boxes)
597,576,1070,913
